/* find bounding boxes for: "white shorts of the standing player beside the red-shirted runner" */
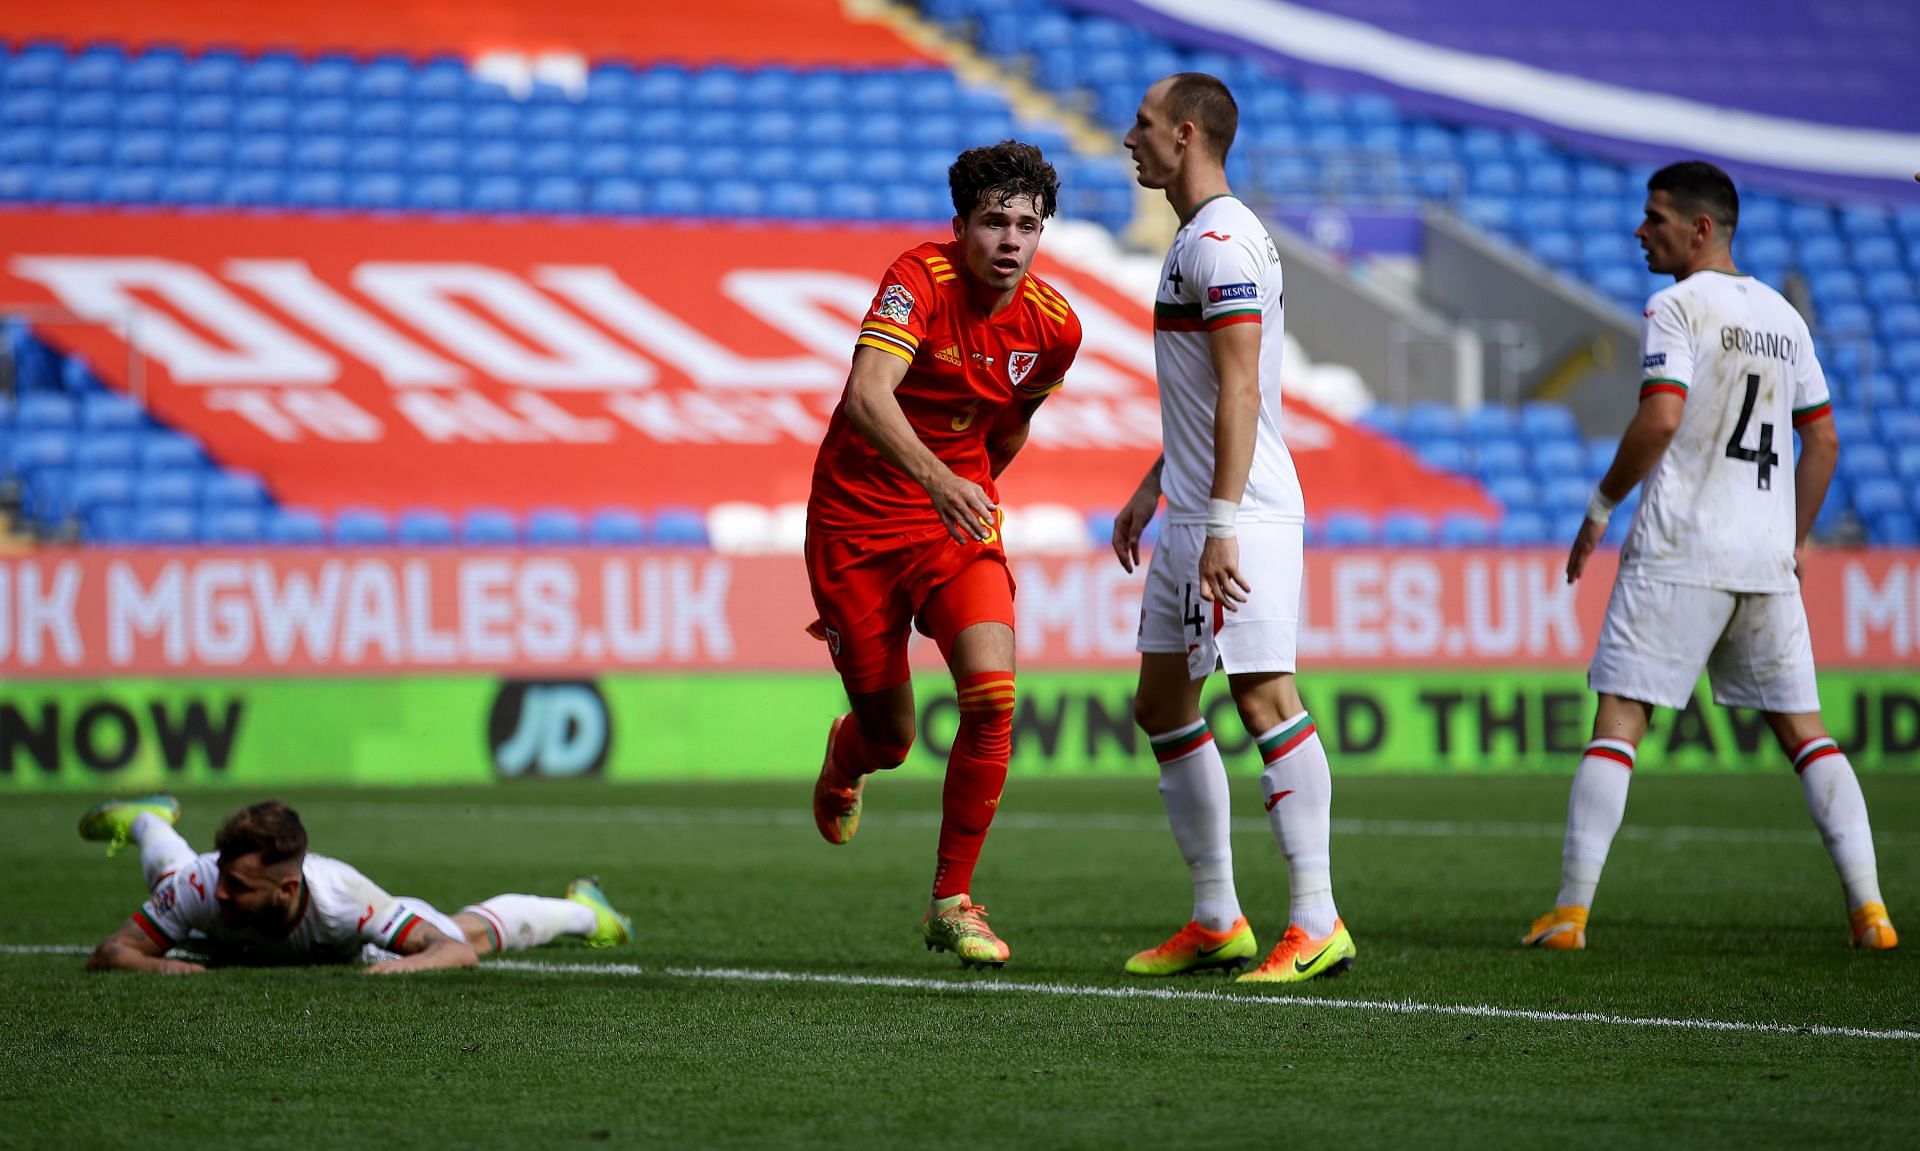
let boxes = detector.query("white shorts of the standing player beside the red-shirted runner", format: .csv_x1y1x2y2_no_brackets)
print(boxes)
1133,523,1302,680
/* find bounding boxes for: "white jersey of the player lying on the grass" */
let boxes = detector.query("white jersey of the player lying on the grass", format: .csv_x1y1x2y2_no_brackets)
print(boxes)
134,851,432,967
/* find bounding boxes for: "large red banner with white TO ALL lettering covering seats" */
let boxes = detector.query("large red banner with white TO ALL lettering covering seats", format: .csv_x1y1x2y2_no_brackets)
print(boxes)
0,211,1494,513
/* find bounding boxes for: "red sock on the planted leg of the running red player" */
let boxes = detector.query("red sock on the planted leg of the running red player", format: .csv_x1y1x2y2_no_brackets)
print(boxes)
933,671,1014,899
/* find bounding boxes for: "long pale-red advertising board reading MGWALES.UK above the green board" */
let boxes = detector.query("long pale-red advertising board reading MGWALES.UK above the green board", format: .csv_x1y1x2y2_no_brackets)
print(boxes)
0,550,1920,678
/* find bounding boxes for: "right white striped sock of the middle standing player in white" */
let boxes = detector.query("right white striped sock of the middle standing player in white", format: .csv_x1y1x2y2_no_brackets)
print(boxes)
1254,711,1340,940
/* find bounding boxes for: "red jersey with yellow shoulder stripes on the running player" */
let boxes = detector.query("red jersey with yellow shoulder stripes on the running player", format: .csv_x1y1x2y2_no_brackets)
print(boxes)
806,240,1081,530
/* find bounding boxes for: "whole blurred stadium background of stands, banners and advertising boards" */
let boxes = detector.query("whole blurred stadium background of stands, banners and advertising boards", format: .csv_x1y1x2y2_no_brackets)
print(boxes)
0,0,1920,792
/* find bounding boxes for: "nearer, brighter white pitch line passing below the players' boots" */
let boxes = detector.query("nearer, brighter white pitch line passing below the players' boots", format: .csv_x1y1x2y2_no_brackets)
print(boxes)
0,943,1920,1040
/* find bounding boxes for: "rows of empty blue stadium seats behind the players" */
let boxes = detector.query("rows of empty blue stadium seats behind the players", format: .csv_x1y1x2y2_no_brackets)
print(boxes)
0,0,1920,546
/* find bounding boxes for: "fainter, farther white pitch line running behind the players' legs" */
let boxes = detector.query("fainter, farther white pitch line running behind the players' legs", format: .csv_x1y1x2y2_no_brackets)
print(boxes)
326,801,1920,847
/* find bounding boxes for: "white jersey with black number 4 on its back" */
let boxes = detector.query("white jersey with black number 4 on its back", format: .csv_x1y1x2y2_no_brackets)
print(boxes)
1620,271,1830,592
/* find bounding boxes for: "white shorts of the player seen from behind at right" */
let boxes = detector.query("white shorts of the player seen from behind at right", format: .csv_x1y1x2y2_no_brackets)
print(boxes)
1586,576,1820,715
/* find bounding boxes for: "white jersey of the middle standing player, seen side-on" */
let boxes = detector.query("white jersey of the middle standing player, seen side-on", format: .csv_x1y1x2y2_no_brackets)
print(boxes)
1154,196,1306,523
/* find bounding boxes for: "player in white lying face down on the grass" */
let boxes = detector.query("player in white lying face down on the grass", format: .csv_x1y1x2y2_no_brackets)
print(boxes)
81,796,634,974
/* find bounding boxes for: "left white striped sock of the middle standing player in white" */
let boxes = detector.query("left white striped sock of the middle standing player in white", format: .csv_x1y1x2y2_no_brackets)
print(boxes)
1146,719,1240,932
